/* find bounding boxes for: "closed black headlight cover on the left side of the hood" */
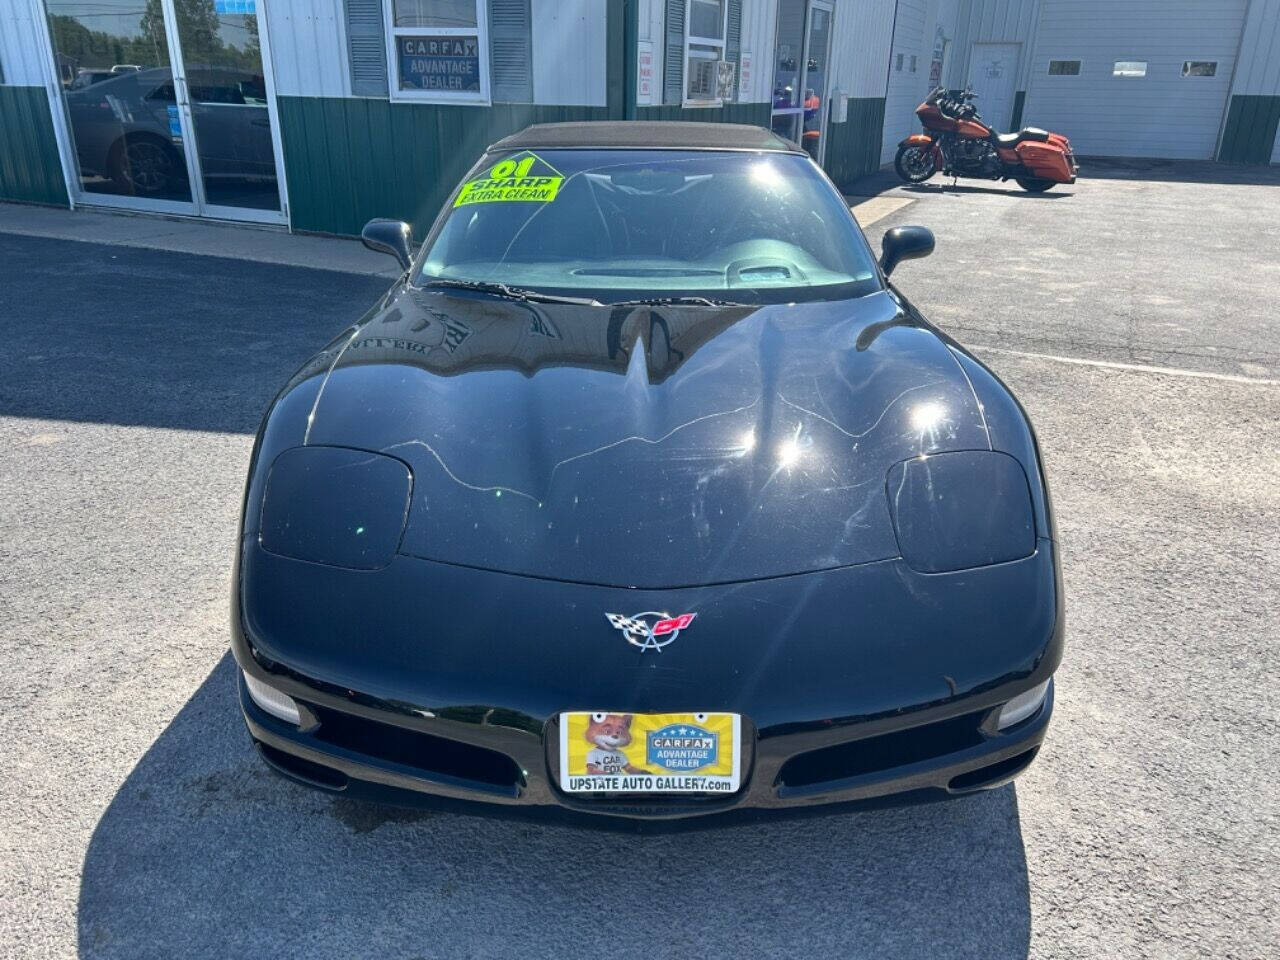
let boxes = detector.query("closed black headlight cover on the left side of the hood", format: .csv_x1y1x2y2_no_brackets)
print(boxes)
259,447,413,570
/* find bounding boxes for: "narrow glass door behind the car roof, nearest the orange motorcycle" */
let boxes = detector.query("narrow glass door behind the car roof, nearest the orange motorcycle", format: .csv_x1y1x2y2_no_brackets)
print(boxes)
772,0,833,163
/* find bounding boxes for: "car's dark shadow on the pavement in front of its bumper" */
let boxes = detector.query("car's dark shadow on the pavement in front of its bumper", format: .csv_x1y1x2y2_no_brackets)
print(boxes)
78,654,1030,960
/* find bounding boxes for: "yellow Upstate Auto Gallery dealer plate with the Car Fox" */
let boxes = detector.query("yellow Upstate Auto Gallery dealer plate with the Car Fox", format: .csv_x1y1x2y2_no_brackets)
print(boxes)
559,712,741,794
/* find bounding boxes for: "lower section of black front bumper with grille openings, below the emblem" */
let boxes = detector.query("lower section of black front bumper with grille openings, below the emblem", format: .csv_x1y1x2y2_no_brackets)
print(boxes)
238,663,1053,826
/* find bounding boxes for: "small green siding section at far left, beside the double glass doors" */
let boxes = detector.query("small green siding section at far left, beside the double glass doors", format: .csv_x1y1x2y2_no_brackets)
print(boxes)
0,86,69,206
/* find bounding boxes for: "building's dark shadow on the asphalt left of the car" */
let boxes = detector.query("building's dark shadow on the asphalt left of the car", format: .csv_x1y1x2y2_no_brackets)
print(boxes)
0,234,390,433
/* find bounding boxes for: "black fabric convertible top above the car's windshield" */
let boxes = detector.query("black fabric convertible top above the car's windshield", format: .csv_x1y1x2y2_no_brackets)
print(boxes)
489,120,803,154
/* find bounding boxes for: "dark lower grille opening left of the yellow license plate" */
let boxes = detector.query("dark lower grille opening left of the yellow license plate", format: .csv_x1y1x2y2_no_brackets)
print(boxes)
307,704,524,790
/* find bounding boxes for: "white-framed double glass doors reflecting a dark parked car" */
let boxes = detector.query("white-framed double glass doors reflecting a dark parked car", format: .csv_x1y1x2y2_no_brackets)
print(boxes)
45,0,285,223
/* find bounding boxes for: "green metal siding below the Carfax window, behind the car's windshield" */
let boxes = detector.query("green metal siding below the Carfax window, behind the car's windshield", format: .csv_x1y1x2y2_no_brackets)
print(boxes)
276,97,608,237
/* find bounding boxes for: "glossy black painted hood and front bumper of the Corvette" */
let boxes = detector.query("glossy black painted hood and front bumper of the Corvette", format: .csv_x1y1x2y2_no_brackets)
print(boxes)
232,267,1064,819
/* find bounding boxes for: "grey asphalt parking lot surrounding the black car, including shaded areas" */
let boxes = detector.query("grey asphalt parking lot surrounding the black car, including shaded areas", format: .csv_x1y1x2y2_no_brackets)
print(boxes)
0,166,1280,960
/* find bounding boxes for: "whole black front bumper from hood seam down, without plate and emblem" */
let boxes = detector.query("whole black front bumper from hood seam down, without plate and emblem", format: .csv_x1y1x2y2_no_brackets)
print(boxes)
232,540,1064,824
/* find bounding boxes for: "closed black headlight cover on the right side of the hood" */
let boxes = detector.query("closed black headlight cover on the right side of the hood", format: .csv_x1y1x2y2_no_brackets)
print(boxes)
887,451,1036,573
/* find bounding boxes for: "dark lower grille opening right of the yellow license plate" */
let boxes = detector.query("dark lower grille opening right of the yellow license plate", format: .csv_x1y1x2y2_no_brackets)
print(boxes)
778,710,986,787
